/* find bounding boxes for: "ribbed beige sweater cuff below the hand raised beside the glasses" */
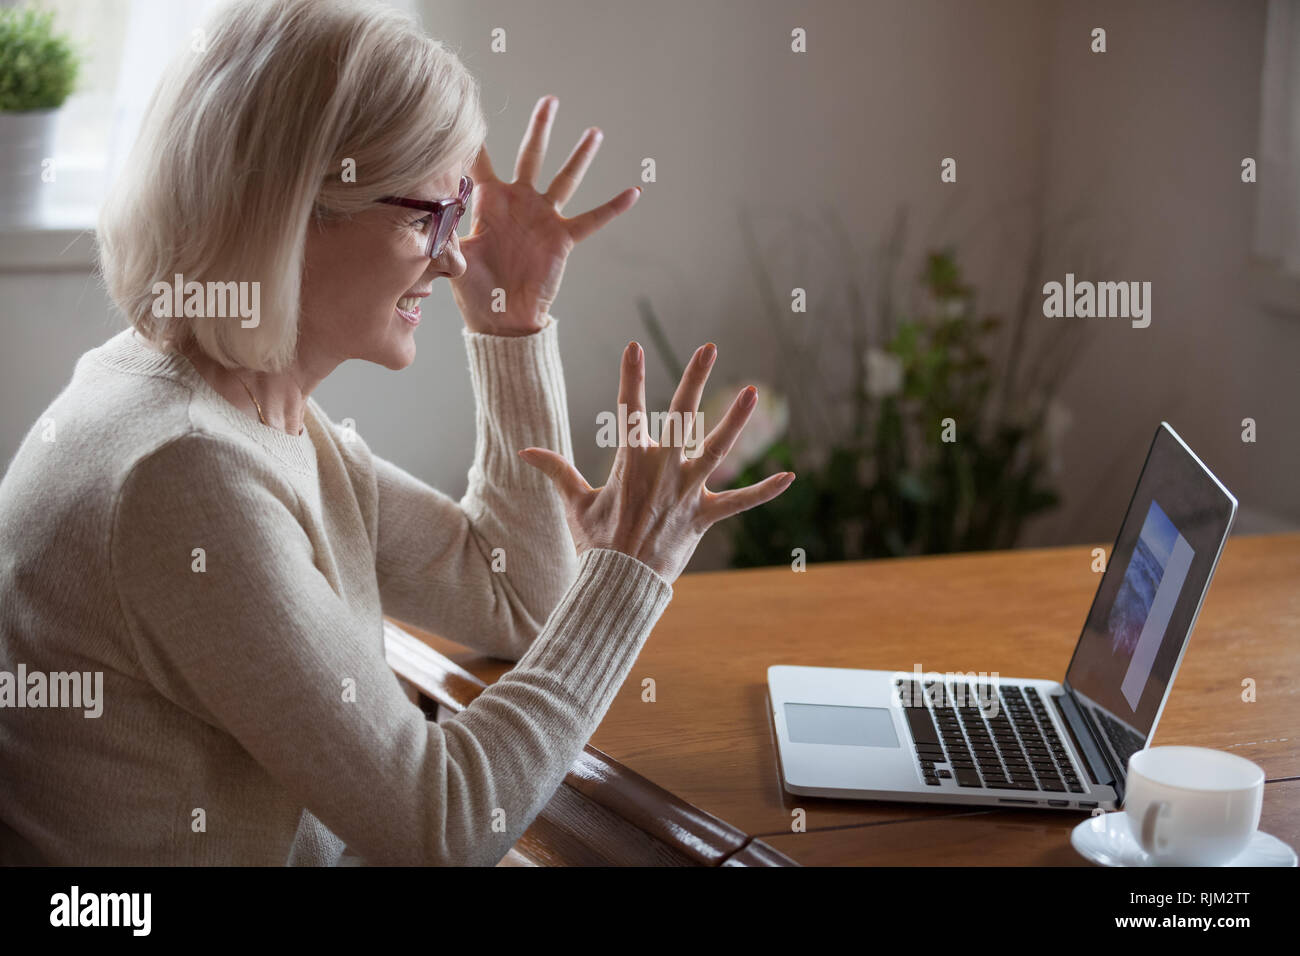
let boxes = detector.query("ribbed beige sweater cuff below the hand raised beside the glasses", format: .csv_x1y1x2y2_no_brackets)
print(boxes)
462,315,573,488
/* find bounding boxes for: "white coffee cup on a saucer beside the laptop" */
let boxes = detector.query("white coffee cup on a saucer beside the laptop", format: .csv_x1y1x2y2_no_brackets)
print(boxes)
1125,747,1264,866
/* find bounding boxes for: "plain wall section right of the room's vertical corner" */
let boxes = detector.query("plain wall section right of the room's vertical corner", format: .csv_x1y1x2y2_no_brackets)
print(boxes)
1035,0,1300,541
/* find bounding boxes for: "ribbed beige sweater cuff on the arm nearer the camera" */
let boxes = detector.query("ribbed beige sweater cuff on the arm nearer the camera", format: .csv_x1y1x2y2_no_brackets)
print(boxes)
507,548,672,718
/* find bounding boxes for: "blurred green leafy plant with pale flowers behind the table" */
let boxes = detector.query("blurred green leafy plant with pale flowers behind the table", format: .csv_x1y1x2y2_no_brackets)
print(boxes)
641,197,1107,567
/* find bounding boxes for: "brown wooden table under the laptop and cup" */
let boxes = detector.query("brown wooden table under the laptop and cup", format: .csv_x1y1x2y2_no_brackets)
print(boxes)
395,533,1300,865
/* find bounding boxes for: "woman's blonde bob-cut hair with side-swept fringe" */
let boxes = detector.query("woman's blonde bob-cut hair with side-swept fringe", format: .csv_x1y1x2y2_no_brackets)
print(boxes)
98,0,488,372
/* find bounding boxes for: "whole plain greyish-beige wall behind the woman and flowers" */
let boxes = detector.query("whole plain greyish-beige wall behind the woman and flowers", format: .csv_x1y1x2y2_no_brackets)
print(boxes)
0,0,1284,570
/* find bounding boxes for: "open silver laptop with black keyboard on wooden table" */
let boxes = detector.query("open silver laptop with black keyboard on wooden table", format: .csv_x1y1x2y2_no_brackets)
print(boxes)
767,421,1236,812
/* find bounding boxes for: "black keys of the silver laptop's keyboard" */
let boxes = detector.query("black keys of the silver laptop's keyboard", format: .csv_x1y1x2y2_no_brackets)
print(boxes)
894,678,1087,793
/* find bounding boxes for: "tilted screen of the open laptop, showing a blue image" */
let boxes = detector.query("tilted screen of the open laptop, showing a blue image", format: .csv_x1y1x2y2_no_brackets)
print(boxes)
1065,423,1236,761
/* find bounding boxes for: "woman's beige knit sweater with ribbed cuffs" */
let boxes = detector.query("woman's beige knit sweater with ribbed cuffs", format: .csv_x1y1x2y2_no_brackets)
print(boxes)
0,320,672,865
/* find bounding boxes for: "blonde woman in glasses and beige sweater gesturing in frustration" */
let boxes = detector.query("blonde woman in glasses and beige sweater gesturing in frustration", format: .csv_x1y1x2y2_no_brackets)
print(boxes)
0,0,793,864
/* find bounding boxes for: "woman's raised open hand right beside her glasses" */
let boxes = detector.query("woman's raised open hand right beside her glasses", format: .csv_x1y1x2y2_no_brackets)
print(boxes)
451,96,641,336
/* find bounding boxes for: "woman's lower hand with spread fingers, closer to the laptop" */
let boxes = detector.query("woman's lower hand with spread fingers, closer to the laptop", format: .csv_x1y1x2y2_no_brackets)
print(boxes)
519,342,794,584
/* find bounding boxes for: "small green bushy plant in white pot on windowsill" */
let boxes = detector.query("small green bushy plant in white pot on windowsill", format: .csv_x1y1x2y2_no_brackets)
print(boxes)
0,4,81,229
